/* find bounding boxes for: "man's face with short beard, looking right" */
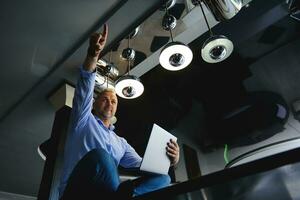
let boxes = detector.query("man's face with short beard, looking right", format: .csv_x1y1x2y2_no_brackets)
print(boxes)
93,91,118,120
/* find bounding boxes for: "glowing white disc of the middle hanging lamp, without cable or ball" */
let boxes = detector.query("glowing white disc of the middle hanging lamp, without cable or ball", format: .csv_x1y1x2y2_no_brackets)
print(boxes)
159,42,193,71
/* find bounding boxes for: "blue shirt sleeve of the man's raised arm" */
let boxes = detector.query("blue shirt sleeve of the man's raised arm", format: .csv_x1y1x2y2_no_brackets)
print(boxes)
71,67,96,129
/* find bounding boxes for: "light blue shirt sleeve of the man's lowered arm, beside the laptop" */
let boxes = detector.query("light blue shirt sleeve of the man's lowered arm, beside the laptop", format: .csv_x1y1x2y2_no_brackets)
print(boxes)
120,139,142,168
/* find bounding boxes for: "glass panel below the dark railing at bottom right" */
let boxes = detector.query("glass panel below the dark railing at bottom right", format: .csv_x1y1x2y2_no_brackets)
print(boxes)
142,163,300,200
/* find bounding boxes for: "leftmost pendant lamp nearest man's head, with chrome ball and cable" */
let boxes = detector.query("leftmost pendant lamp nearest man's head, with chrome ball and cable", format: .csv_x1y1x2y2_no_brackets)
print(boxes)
115,37,144,99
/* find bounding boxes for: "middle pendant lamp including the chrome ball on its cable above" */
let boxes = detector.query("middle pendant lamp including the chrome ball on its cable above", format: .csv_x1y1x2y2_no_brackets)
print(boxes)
159,2,193,71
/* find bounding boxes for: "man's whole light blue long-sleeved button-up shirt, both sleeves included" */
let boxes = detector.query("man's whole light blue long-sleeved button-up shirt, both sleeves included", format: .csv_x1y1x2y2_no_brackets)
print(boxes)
59,69,142,197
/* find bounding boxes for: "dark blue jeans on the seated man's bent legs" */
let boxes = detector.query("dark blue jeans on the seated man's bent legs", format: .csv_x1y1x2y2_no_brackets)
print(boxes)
62,149,171,200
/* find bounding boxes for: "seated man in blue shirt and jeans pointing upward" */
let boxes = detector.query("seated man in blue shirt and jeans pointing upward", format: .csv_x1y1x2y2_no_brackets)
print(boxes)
59,25,179,200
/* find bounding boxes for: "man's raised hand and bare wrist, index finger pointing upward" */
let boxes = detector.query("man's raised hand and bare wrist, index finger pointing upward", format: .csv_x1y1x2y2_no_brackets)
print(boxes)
83,24,108,72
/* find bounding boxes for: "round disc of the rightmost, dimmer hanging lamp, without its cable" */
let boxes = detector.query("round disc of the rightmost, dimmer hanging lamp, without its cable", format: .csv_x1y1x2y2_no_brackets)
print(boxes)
201,35,233,63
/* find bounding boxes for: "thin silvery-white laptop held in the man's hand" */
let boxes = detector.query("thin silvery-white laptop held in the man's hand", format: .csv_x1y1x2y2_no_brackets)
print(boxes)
140,124,177,174
